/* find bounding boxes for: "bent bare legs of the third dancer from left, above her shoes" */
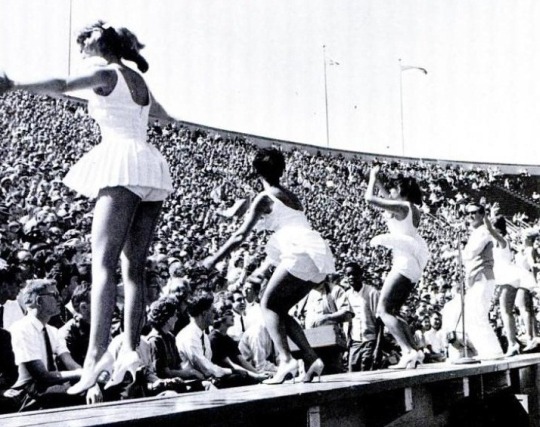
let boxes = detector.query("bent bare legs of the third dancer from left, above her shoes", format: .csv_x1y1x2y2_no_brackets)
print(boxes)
377,271,417,355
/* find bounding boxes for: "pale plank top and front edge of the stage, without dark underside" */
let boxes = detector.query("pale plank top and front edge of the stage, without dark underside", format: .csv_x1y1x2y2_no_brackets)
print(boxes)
0,355,540,427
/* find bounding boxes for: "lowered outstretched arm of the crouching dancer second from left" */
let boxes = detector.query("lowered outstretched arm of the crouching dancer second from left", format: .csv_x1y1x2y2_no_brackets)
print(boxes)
203,193,273,268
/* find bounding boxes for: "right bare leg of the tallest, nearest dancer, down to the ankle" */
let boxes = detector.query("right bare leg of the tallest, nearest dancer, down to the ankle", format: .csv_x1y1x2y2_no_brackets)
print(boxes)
121,202,163,351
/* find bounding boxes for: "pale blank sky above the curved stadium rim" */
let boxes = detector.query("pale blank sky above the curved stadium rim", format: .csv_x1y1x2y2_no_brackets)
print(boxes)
0,0,540,164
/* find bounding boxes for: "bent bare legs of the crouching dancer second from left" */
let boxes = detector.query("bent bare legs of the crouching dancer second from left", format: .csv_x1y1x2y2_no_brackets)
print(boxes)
261,266,317,364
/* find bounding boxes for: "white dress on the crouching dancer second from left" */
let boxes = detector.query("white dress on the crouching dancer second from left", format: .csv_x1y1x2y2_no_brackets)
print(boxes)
257,193,336,283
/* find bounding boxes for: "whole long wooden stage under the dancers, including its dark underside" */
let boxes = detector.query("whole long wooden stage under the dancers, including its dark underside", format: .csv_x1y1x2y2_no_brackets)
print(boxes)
0,354,540,427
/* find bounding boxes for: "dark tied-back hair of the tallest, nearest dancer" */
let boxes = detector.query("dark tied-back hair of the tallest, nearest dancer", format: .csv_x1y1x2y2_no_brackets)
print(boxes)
77,20,148,73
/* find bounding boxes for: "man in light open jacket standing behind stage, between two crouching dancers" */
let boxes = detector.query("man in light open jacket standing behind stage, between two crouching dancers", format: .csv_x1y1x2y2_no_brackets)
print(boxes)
344,262,382,372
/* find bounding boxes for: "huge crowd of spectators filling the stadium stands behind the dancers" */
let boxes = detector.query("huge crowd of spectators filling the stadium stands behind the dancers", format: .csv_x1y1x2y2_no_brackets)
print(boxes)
0,92,540,411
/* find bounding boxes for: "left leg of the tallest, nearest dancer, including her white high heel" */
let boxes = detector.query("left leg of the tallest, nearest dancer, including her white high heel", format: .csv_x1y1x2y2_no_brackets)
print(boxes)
70,187,140,394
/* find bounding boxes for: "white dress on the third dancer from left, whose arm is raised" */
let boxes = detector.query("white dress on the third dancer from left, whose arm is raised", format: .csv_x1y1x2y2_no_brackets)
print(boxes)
371,206,429,283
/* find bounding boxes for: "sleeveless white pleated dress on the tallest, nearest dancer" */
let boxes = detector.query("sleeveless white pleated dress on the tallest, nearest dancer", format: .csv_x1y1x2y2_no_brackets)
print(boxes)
64,66,173,197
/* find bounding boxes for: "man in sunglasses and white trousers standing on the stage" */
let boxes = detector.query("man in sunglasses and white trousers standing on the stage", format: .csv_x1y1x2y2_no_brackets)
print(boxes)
463,204,504,359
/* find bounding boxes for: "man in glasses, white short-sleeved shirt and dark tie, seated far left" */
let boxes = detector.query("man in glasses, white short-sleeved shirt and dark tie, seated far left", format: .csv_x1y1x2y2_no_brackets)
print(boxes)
6,279,102,410
